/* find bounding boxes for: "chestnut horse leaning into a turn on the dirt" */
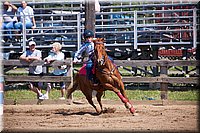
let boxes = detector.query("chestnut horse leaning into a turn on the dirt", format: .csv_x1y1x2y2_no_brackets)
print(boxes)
67,38,135,114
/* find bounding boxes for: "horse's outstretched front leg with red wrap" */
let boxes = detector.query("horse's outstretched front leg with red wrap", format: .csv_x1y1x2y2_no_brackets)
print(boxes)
105,83,135,114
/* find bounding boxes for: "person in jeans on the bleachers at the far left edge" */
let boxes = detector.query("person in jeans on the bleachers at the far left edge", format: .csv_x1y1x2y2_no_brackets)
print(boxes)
2,1,17,42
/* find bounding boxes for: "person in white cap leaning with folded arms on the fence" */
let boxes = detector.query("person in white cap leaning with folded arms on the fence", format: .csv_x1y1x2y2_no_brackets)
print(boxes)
19,41,43,98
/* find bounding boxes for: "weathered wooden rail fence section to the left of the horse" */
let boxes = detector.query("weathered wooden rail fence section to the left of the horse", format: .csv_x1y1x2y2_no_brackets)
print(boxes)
2,58,73,83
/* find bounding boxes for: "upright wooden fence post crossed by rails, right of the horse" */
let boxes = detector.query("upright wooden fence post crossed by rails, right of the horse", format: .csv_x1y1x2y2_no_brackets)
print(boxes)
160,65,168,100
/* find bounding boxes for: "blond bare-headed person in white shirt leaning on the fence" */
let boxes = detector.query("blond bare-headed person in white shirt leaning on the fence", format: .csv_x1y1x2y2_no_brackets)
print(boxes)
39,42,67,100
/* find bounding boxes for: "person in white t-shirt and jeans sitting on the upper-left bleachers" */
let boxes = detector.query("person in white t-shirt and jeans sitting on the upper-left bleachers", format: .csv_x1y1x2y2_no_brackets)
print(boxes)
15,1,36,30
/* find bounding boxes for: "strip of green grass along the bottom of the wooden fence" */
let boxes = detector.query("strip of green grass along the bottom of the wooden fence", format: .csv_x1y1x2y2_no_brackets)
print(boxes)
4,89,200,101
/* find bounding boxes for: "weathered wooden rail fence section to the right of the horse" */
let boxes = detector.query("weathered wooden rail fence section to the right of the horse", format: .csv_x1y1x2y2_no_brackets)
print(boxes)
115,60,200,99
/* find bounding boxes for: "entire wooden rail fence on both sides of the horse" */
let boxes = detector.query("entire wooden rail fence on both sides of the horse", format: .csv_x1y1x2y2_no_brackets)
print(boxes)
2,58,200,99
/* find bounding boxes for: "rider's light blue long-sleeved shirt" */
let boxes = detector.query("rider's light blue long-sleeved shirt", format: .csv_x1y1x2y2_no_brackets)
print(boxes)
74,41,94,61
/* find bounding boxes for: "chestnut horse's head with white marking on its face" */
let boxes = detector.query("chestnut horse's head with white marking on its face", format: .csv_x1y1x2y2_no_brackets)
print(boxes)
94,38,107,65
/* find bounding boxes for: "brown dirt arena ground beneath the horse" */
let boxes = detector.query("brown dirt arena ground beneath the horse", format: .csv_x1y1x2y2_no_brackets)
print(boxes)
3,100,199,132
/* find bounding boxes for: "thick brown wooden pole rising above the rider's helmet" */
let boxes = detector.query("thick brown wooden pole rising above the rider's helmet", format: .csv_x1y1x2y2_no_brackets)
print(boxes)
85,0,95,33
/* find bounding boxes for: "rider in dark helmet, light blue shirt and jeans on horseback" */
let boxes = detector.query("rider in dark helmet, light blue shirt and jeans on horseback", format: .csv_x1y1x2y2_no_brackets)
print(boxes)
73,30,98,86
